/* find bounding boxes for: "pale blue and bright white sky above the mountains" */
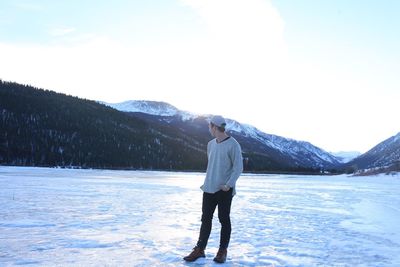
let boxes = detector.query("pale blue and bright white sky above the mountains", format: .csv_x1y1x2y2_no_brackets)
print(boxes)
0,0,400,152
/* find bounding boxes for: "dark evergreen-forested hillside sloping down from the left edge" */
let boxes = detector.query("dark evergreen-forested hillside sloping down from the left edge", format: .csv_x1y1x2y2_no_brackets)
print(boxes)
0,81,206,170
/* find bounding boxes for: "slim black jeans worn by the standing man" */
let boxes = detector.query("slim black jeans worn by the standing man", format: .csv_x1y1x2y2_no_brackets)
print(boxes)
197,188,233,249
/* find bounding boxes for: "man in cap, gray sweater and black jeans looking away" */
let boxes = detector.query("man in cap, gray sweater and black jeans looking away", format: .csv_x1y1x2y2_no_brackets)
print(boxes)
183,116,243,263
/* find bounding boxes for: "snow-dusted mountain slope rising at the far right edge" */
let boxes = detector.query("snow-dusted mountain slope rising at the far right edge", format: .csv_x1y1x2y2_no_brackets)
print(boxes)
348,132,400,169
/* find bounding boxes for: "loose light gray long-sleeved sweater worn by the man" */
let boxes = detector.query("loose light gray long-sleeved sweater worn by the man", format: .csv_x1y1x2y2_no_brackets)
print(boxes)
201,137,243,195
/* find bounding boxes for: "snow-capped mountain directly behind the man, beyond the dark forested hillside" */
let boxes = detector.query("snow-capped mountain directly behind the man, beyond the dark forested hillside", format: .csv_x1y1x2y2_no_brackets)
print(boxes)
108,101,340,169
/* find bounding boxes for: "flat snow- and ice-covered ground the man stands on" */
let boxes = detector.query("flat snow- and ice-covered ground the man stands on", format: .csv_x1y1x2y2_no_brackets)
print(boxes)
0,167,400,266
